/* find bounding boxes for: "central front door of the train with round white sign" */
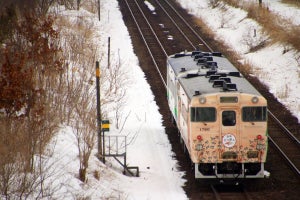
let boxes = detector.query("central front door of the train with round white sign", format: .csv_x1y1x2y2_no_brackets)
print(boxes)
220,108,240,161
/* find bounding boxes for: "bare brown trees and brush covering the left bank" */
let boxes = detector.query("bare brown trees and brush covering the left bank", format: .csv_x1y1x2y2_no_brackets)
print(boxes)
0,0,130,199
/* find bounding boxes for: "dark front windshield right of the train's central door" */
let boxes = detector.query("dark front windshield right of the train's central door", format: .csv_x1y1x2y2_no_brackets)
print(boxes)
242,106,267,122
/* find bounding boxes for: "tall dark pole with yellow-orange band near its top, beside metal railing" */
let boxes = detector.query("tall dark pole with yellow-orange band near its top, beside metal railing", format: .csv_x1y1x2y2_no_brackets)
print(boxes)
96,61,103,159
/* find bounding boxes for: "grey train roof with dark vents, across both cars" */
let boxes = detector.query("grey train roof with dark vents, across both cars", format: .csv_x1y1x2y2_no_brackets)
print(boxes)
168,51,261,99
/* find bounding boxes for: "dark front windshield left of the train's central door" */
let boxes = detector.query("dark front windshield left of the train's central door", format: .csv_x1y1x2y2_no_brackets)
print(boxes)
191,107,216,122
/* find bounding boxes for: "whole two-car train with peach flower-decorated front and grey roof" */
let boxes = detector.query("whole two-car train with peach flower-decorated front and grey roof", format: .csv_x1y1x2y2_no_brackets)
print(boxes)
167,51,268,179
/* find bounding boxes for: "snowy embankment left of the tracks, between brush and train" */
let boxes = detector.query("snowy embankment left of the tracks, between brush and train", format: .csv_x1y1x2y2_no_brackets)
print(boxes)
43,0,187,200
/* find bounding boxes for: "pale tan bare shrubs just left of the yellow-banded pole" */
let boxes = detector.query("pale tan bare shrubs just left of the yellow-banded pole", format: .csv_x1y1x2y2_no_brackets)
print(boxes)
54,12,98,182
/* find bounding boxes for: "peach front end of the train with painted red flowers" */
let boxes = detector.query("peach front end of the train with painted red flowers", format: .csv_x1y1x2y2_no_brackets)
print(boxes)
191,93,268,179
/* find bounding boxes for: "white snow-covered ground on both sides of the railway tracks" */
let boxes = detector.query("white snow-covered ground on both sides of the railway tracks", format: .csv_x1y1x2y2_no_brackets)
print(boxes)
40,0,300,200
